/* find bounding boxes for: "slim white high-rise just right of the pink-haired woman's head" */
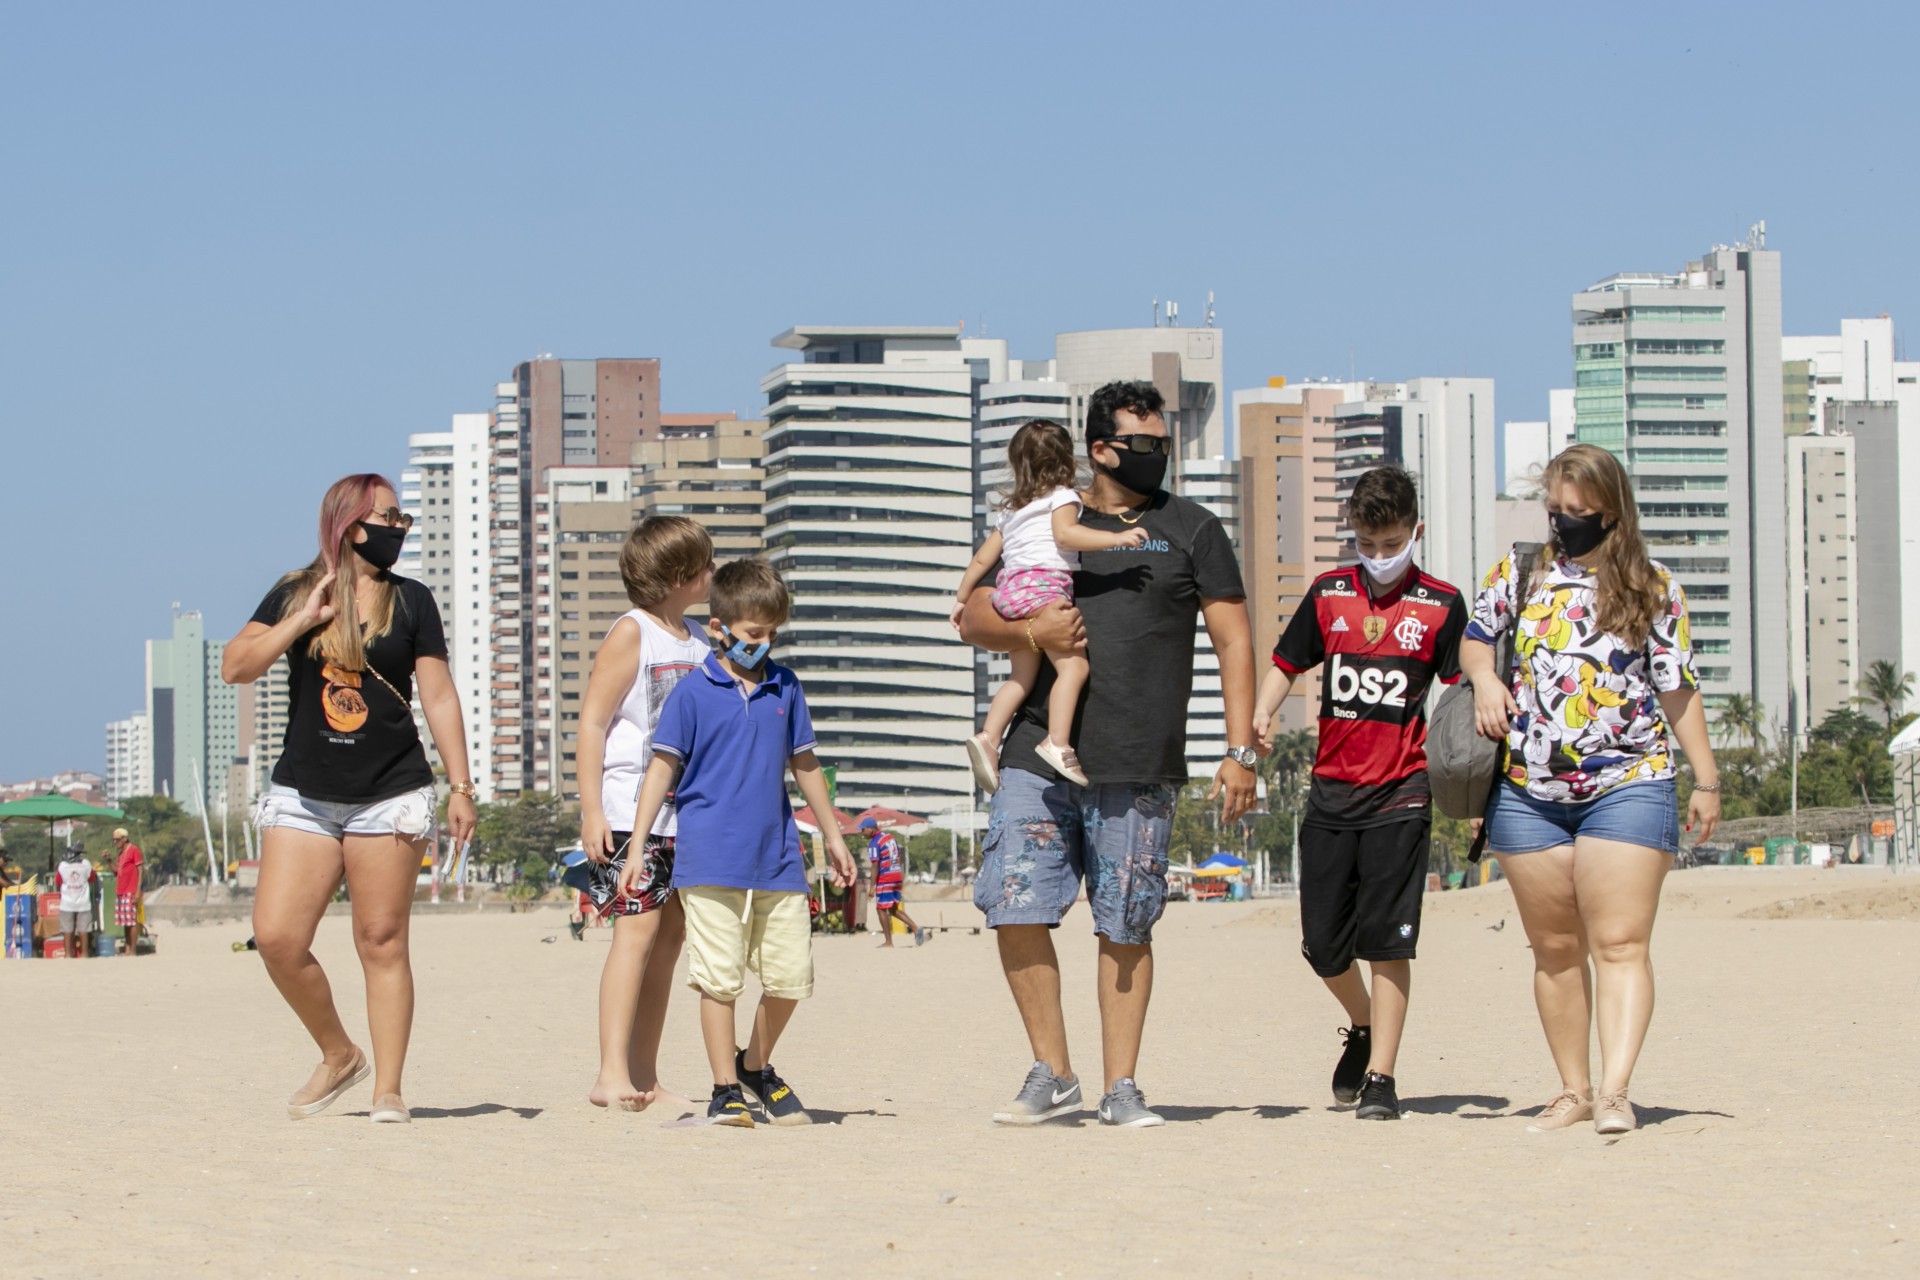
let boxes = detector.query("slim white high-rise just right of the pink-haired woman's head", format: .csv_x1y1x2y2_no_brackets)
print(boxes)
396,413,493,800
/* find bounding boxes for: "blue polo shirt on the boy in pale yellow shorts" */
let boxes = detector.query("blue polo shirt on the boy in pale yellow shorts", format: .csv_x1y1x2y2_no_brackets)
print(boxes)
653,654,814,892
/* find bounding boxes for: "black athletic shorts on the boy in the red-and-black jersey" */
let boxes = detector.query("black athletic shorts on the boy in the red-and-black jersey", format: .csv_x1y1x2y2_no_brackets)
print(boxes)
1300,814,1432,979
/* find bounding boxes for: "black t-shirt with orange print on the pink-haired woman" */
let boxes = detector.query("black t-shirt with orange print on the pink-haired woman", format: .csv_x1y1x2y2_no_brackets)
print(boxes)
253,574,447,804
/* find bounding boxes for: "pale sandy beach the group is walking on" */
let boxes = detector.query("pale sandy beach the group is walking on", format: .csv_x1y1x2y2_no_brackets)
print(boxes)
0,869,1920,1276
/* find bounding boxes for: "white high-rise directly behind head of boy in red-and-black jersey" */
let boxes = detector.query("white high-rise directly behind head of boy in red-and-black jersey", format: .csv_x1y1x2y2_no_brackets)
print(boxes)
1308,378,1505,595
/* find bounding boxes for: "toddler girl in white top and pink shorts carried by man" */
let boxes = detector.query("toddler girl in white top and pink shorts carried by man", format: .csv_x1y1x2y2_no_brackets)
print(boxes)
952,418,1146,796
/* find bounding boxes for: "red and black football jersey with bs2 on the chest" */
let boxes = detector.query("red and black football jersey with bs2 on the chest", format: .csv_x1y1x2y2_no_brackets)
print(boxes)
1273,566,1467,827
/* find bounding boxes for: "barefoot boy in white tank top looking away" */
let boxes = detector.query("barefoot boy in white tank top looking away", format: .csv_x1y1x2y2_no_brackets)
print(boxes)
574,516,714,1111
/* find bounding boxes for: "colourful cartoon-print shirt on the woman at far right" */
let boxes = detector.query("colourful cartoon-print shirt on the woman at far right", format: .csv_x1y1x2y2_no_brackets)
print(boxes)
1467,555,1699,804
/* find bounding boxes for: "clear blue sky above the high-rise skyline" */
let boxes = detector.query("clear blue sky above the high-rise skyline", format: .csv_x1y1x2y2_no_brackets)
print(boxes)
0,2,1920,779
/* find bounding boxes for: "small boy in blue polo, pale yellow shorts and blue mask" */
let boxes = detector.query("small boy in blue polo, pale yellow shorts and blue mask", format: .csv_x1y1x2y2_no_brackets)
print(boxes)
620,560,854,1128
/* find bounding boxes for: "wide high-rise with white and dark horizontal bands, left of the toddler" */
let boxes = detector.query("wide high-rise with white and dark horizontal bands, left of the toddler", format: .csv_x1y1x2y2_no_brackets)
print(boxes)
760,324,1006,814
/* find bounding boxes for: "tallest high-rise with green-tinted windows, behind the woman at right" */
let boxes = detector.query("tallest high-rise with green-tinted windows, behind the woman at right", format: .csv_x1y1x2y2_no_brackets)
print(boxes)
1572,228,1791,706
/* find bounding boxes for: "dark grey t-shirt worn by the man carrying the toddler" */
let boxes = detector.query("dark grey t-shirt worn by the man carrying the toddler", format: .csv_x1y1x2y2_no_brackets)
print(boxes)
1000,489,1246,787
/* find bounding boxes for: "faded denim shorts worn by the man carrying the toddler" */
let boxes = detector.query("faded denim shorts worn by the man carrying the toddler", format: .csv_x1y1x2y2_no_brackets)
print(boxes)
973,770,1177,946
